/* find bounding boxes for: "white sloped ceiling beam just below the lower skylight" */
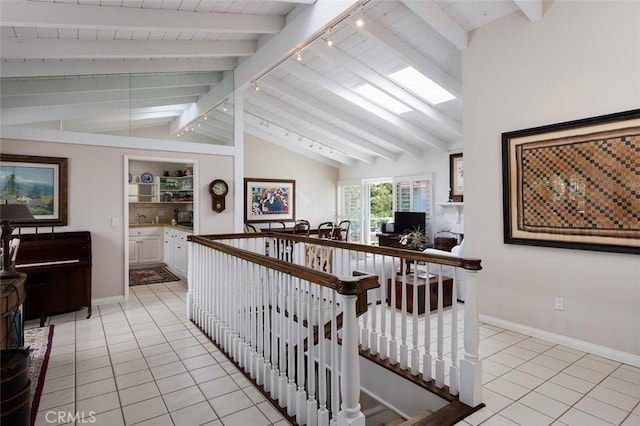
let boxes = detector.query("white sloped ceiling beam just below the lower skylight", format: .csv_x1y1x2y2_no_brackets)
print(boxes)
281,61,448,150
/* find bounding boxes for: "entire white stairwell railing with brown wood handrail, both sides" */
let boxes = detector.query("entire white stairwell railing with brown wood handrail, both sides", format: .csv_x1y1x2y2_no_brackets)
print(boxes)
187,232,482,425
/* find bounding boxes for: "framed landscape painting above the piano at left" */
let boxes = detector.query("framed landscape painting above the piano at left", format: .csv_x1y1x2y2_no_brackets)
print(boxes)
0,154,68,226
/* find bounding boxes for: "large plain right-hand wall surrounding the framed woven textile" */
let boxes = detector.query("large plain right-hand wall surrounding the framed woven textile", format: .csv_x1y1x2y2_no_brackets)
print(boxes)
463,2,640,363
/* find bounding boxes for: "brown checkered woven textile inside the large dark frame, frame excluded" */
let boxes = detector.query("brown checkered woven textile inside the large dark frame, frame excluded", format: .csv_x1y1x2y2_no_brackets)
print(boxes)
516,129,640,238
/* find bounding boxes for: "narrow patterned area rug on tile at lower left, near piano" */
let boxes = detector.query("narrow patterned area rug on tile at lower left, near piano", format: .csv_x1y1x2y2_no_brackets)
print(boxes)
24,325,53,426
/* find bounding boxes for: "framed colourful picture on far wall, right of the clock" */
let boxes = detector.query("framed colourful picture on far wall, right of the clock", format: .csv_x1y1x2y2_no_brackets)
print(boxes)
244,178,296,223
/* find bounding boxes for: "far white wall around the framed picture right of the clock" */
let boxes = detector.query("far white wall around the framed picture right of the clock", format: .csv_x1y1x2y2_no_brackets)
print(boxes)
244,133,338,227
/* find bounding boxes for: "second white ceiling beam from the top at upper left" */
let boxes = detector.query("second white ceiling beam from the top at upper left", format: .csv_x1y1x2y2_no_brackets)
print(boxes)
2,39,256,59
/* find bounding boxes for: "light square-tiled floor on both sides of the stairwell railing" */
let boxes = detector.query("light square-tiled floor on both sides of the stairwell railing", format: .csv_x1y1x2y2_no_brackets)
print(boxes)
25,283,640,426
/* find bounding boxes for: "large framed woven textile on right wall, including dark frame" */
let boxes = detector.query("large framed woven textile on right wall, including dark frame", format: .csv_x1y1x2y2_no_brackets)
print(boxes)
502,109,640,254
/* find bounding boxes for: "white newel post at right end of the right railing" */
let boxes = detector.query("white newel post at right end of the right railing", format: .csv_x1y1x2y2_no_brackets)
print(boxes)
460,270,482,407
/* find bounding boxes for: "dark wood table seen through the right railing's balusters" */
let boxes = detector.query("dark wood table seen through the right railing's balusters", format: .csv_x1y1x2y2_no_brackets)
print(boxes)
387,275,453,315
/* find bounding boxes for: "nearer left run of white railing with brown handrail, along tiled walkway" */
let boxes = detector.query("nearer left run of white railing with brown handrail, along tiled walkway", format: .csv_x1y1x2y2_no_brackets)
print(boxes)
187,237,378,426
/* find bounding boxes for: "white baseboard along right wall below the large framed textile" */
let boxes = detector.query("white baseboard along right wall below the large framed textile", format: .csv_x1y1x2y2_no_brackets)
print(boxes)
479,314,640,367
